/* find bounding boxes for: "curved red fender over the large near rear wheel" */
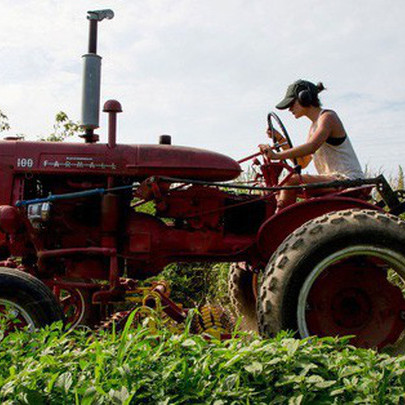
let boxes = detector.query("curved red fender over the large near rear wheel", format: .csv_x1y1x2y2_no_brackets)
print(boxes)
256,197,381,263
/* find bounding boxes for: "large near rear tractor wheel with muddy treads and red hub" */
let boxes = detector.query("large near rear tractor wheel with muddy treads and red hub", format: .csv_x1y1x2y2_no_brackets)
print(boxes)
257,210,405,352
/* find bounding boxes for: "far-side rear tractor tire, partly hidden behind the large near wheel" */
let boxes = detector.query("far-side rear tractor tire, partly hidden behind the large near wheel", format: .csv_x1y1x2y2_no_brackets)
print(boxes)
228,263,258,332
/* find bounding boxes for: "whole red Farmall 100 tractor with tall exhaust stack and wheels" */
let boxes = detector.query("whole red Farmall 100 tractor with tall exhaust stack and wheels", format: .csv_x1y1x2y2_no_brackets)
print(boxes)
0,10,405,351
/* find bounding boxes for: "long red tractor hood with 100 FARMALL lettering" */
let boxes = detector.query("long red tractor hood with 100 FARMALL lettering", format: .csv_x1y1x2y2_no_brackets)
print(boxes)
0,141,241,181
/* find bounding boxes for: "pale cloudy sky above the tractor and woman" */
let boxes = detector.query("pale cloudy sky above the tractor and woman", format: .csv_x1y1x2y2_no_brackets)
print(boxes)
0,0,405,176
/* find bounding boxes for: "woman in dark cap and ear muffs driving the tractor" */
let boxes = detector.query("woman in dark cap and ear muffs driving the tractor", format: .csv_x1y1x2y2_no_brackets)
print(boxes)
259,80,364,210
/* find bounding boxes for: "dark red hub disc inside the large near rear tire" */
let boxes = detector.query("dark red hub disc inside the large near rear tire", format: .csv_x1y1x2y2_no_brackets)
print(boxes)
297,245,405,349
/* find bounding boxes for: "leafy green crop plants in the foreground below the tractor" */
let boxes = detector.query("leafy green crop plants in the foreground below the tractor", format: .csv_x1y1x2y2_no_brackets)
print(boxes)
0,312,405,405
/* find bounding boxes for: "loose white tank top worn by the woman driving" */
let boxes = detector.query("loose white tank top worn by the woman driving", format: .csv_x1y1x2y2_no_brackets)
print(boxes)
313,110,364,180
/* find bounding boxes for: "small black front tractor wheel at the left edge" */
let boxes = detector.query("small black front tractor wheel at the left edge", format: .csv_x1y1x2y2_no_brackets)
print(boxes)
0,267,64,334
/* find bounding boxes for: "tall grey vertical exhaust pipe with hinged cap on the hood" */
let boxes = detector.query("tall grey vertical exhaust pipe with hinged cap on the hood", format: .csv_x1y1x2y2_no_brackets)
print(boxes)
81,10,114,143
